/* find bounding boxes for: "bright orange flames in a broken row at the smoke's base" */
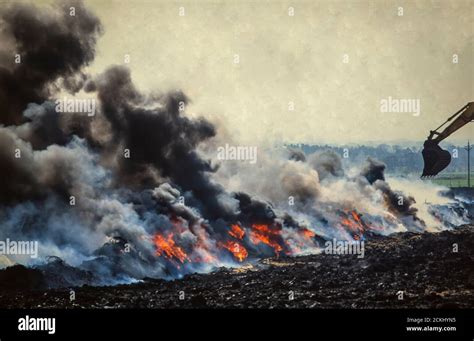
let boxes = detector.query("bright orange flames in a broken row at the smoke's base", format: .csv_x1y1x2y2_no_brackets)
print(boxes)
153,210,372,268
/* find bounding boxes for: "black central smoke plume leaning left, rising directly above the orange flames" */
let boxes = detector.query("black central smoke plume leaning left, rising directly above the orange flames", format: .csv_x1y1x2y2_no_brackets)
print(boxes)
89,66,235,218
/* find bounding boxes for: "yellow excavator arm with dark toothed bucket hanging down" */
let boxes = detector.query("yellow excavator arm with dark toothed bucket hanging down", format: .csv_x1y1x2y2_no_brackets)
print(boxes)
421,102,474,177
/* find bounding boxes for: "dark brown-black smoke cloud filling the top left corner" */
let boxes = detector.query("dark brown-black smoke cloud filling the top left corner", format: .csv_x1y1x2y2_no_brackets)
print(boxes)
0,1,101,125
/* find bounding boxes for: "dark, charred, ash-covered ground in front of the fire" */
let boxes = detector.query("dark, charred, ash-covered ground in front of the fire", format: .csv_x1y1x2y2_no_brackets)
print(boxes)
0,225,474,308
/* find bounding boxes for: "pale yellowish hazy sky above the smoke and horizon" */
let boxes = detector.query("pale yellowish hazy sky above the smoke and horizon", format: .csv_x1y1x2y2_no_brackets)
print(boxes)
12,0,474,144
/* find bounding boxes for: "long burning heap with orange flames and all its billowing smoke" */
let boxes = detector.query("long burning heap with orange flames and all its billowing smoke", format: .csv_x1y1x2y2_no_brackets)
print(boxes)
0,2,470,286
